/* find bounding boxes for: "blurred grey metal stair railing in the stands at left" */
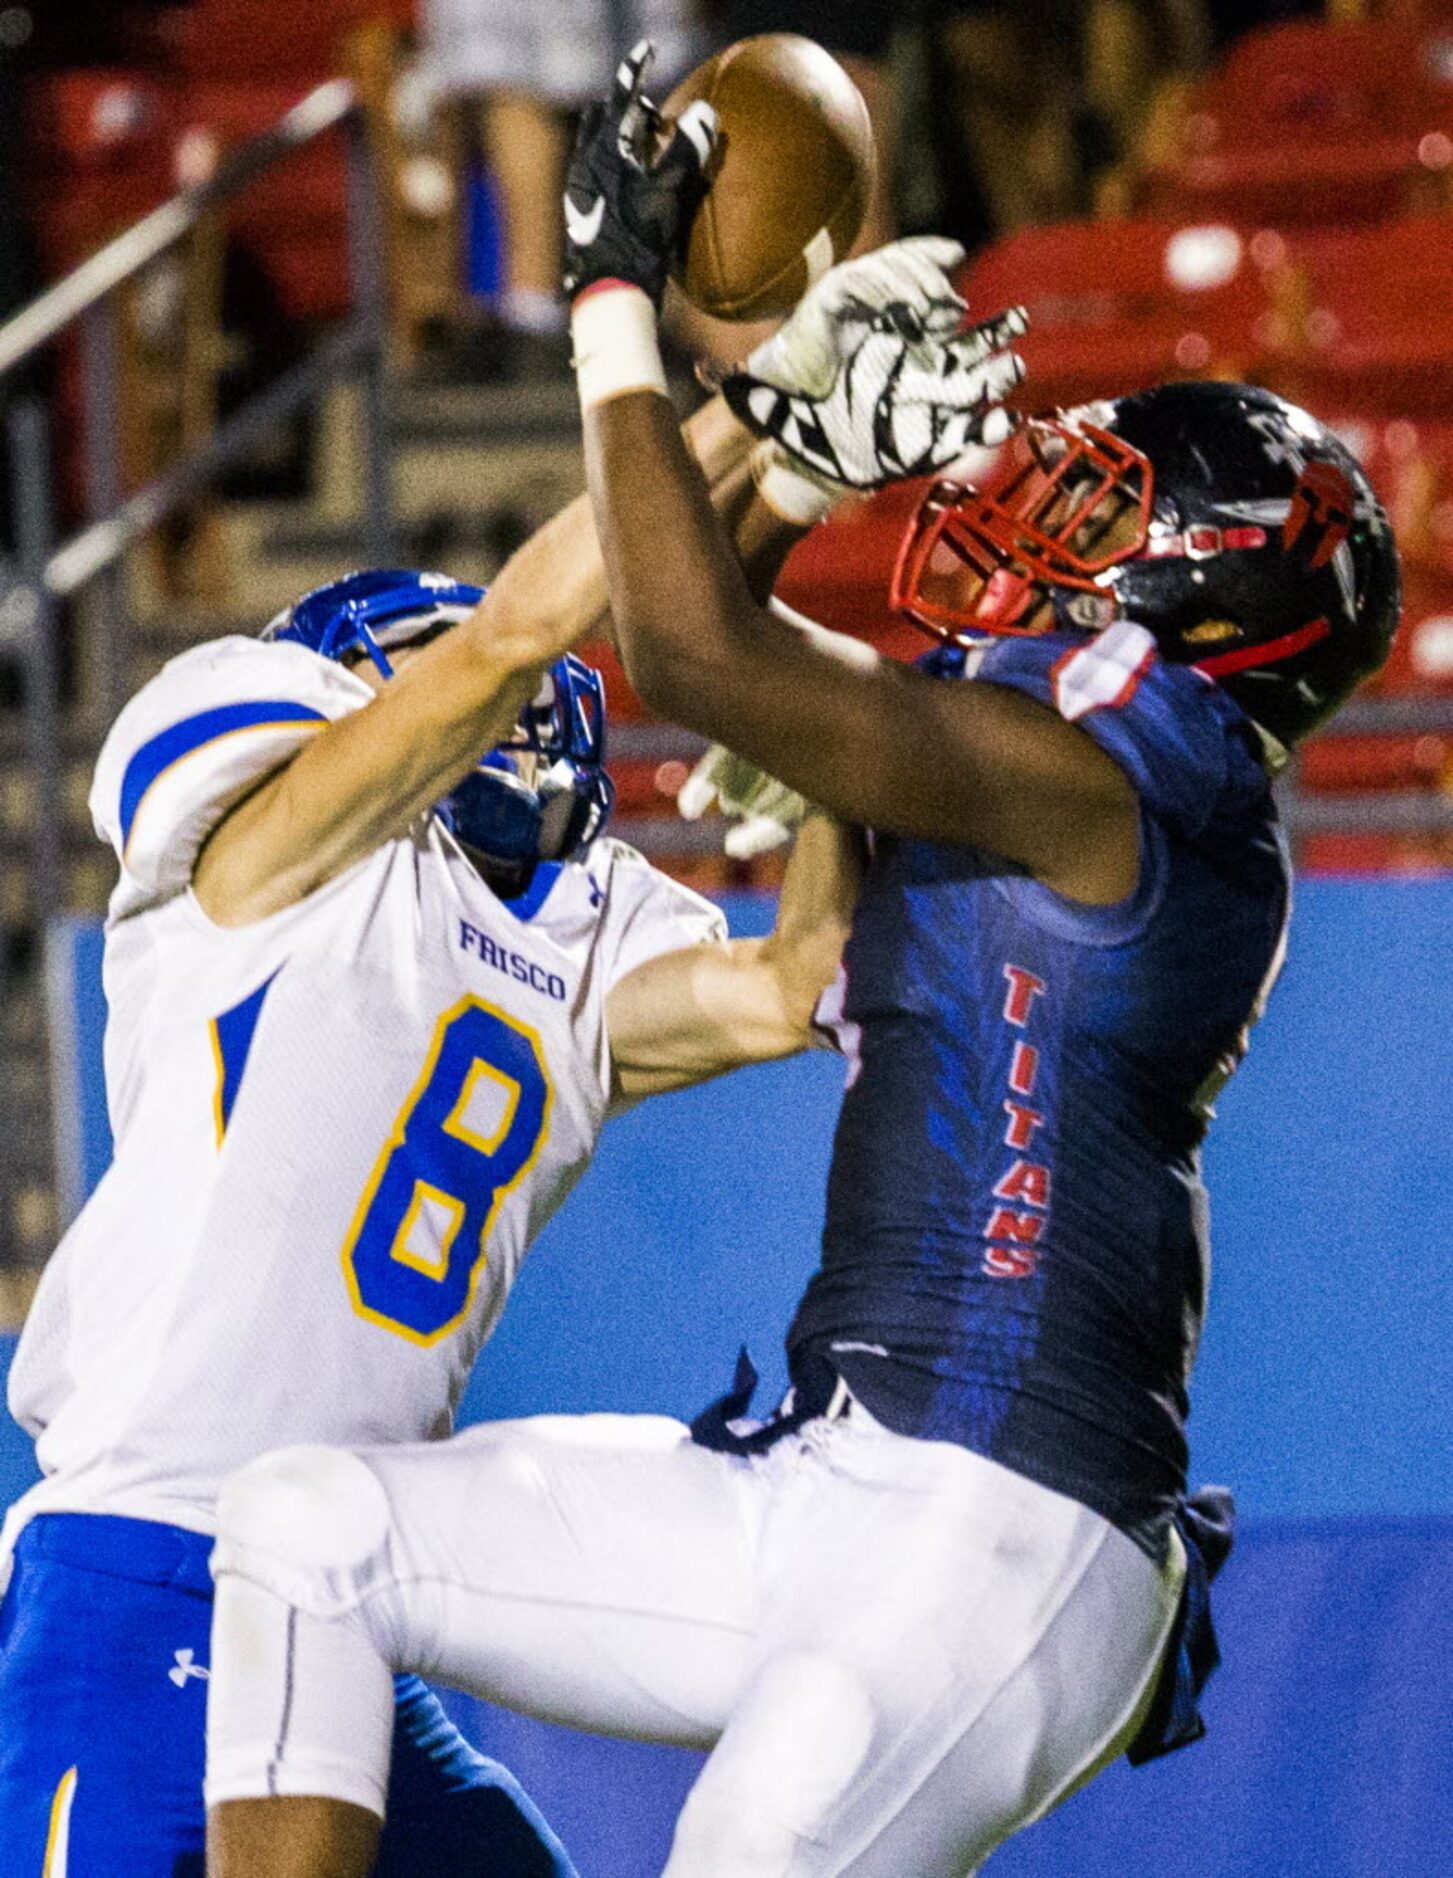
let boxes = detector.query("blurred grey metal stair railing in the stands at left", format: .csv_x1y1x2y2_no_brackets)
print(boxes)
0,79,392,922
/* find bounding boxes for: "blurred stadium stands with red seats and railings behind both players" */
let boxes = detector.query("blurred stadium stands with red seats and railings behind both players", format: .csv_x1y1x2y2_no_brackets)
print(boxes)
0,0,1453,1284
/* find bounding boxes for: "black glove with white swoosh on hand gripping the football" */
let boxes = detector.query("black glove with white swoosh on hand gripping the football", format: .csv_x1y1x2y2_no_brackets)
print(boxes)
565,39,717,306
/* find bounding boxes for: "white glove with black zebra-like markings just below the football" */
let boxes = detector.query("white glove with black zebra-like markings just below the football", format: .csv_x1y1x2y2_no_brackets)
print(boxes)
721,237,1027,488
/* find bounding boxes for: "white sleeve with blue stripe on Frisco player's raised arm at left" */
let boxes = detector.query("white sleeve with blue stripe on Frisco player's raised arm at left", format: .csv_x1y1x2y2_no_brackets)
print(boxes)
90,637,372,913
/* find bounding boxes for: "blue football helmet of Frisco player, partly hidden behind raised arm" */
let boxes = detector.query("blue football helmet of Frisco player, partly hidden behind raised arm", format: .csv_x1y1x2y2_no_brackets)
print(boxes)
263,567,616,871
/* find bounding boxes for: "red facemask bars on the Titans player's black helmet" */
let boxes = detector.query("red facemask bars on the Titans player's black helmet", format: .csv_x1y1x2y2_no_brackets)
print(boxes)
890,417,1153,644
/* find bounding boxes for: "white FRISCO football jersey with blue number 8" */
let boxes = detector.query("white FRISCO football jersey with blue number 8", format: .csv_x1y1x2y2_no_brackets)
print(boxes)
8,639,725,1538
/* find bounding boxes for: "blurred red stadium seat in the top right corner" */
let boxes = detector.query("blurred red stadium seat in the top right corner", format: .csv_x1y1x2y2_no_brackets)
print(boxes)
1143,21,1453,225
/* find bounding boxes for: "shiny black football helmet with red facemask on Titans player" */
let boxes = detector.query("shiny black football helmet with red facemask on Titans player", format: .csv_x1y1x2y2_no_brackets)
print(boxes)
894,383,1400,747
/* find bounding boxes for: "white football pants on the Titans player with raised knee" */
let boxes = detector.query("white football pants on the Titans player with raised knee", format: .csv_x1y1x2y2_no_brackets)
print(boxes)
206,1403,1185,1878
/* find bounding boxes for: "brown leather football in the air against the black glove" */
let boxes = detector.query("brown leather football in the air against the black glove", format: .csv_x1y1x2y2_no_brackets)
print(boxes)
663,32,877,319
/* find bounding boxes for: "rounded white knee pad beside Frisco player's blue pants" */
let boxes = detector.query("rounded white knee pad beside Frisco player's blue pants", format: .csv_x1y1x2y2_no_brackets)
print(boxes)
212,1448,389,1617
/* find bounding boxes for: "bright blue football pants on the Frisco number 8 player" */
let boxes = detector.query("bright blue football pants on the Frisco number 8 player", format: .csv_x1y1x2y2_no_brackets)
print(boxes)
0,1514,574,1878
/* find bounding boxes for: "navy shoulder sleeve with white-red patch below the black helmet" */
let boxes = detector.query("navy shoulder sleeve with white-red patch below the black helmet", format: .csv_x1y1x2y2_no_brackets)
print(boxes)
974,620,1254,836
